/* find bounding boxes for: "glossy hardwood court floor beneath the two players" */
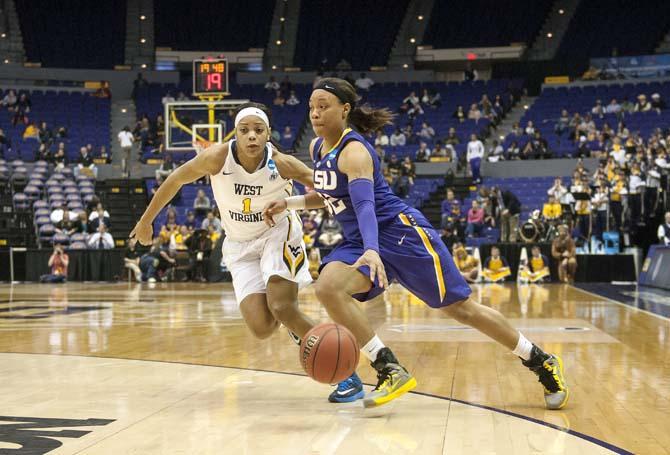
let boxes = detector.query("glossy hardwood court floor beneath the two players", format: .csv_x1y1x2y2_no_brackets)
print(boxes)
0,283,670,454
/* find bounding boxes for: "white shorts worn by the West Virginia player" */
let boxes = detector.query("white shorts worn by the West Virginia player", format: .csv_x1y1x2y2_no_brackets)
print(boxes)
223,212,312,303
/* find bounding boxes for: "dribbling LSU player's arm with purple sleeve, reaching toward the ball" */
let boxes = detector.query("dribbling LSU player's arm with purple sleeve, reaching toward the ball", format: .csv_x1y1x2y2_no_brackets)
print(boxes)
338,142,388,288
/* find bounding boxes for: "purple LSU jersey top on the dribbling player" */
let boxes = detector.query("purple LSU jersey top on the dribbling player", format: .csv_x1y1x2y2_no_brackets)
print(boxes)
314,128,409,242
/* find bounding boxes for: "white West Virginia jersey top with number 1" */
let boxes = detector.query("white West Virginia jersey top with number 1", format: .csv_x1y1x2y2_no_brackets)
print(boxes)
210,139,293,242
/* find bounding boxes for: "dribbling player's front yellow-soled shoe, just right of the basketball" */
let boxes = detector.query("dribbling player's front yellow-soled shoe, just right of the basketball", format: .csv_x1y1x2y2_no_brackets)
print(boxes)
363,348,416,408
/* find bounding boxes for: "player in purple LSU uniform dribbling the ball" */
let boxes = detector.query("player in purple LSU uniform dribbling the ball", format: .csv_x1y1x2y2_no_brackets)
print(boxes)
264,78,569,409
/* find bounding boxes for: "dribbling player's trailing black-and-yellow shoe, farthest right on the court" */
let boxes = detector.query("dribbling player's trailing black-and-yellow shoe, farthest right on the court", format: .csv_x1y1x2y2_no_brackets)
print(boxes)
522,346,570,409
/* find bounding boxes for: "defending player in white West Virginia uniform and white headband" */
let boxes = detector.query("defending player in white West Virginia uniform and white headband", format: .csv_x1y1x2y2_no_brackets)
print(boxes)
130,103,314,348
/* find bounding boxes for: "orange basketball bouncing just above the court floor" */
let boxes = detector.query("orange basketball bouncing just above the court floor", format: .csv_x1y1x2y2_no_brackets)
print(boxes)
300,323,359,384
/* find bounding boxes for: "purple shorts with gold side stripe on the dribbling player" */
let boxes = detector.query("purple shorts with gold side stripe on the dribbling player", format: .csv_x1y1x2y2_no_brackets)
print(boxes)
322,208,472,308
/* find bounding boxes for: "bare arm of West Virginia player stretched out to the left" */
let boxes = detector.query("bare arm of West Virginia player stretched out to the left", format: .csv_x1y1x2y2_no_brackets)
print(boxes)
130,144,228,245
